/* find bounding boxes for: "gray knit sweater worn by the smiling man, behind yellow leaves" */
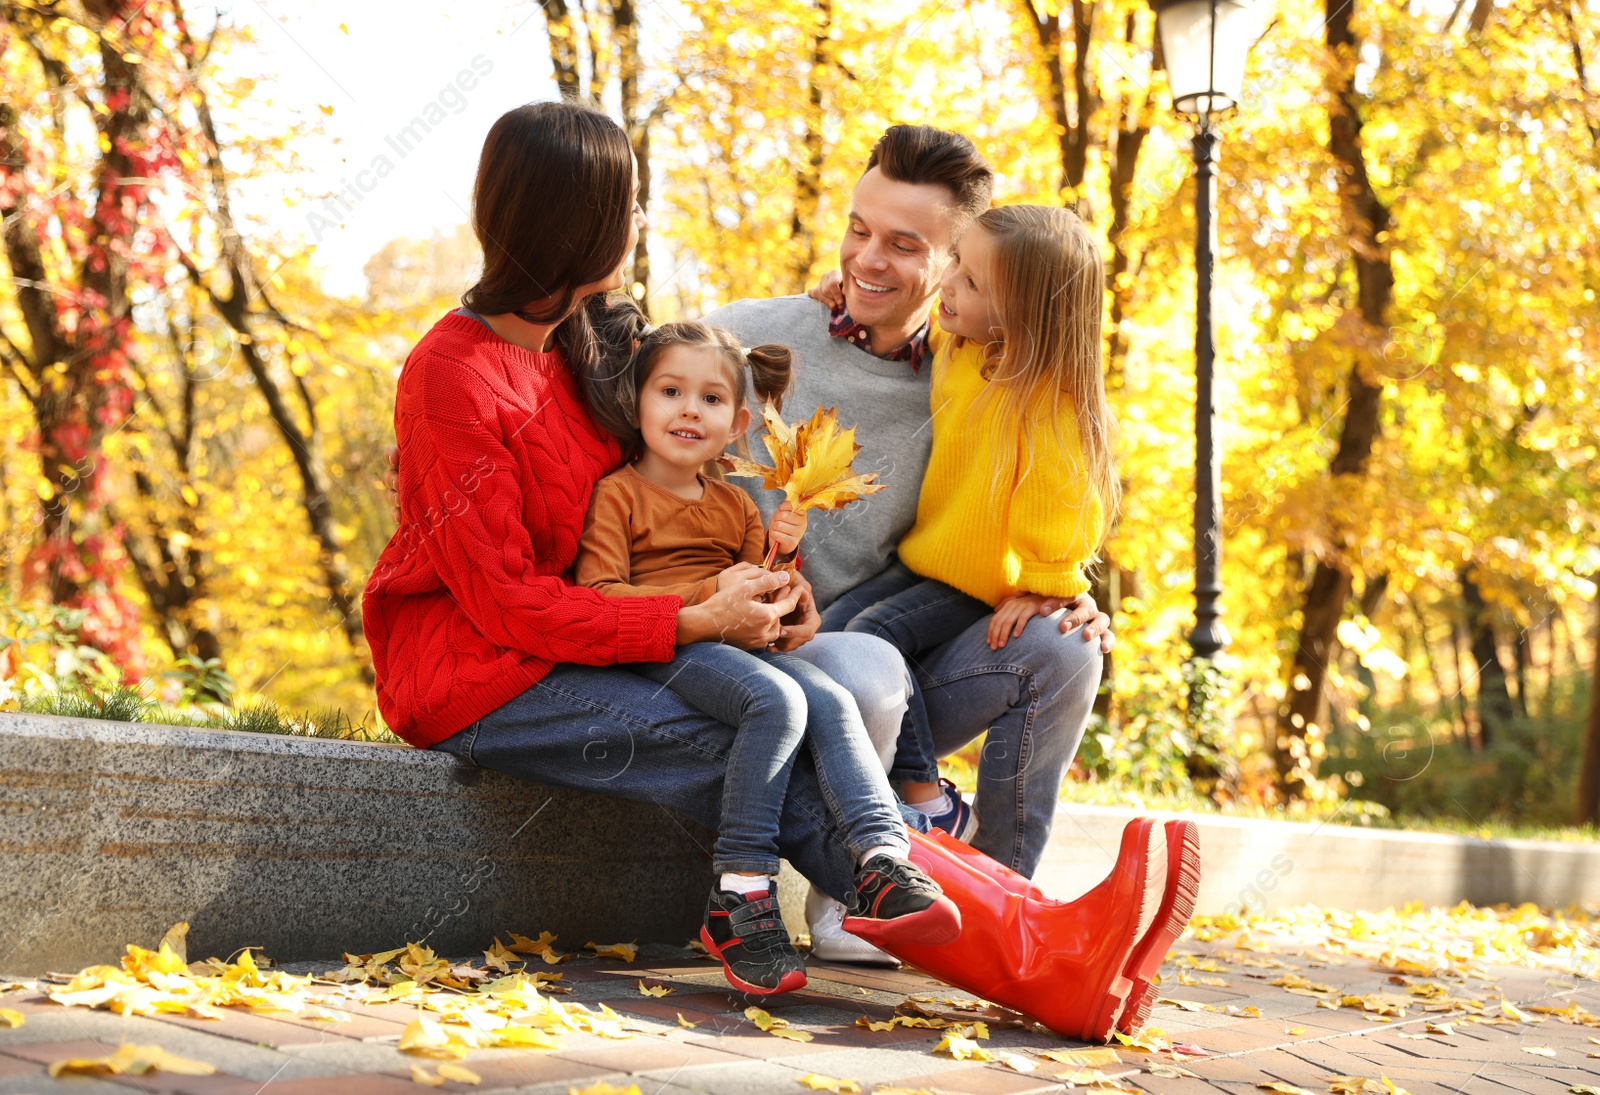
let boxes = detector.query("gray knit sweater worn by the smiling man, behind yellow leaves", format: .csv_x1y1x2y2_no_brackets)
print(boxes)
706,296,933,608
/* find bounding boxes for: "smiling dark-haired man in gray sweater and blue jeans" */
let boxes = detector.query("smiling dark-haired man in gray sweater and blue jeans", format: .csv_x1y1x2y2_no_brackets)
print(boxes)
706,125,1112,961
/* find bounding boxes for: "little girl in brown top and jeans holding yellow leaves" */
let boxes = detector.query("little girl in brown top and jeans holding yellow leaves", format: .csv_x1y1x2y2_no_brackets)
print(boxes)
573,323,960,994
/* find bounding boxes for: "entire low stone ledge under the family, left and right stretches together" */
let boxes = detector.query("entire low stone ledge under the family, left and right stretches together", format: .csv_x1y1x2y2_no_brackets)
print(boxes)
0,714,1600,973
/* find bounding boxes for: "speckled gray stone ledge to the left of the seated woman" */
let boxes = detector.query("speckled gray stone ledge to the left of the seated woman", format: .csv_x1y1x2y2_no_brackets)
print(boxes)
0,714,712,973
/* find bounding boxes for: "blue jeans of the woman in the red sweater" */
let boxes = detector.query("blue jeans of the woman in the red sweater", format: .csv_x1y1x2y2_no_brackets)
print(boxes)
434,636,928,901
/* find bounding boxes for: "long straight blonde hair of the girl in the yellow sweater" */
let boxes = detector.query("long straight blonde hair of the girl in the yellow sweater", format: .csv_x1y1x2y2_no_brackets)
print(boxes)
974,205,1122,541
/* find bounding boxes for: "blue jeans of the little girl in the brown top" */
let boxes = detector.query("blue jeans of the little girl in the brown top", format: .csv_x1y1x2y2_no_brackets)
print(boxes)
630,642,906,874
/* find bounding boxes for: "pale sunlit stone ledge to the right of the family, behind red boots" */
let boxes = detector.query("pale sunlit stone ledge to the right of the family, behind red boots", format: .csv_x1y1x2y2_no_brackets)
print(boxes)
1035,805,1600,914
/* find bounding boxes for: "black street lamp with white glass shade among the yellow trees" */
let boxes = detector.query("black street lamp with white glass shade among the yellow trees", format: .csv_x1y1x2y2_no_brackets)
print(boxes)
1152,0,1258,658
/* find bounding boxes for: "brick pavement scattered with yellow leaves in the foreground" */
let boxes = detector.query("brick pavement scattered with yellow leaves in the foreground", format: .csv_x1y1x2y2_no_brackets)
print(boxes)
0,937,1600,1095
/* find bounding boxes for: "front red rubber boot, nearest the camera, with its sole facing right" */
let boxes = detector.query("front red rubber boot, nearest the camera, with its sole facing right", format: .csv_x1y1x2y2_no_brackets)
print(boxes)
861,818,1166,1042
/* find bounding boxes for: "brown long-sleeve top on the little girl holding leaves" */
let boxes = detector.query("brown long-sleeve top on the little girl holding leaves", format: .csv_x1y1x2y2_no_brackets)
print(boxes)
573,464,766,605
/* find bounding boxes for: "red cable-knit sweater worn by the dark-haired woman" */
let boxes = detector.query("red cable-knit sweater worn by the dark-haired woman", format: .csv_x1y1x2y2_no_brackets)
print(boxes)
362,312,682,748
